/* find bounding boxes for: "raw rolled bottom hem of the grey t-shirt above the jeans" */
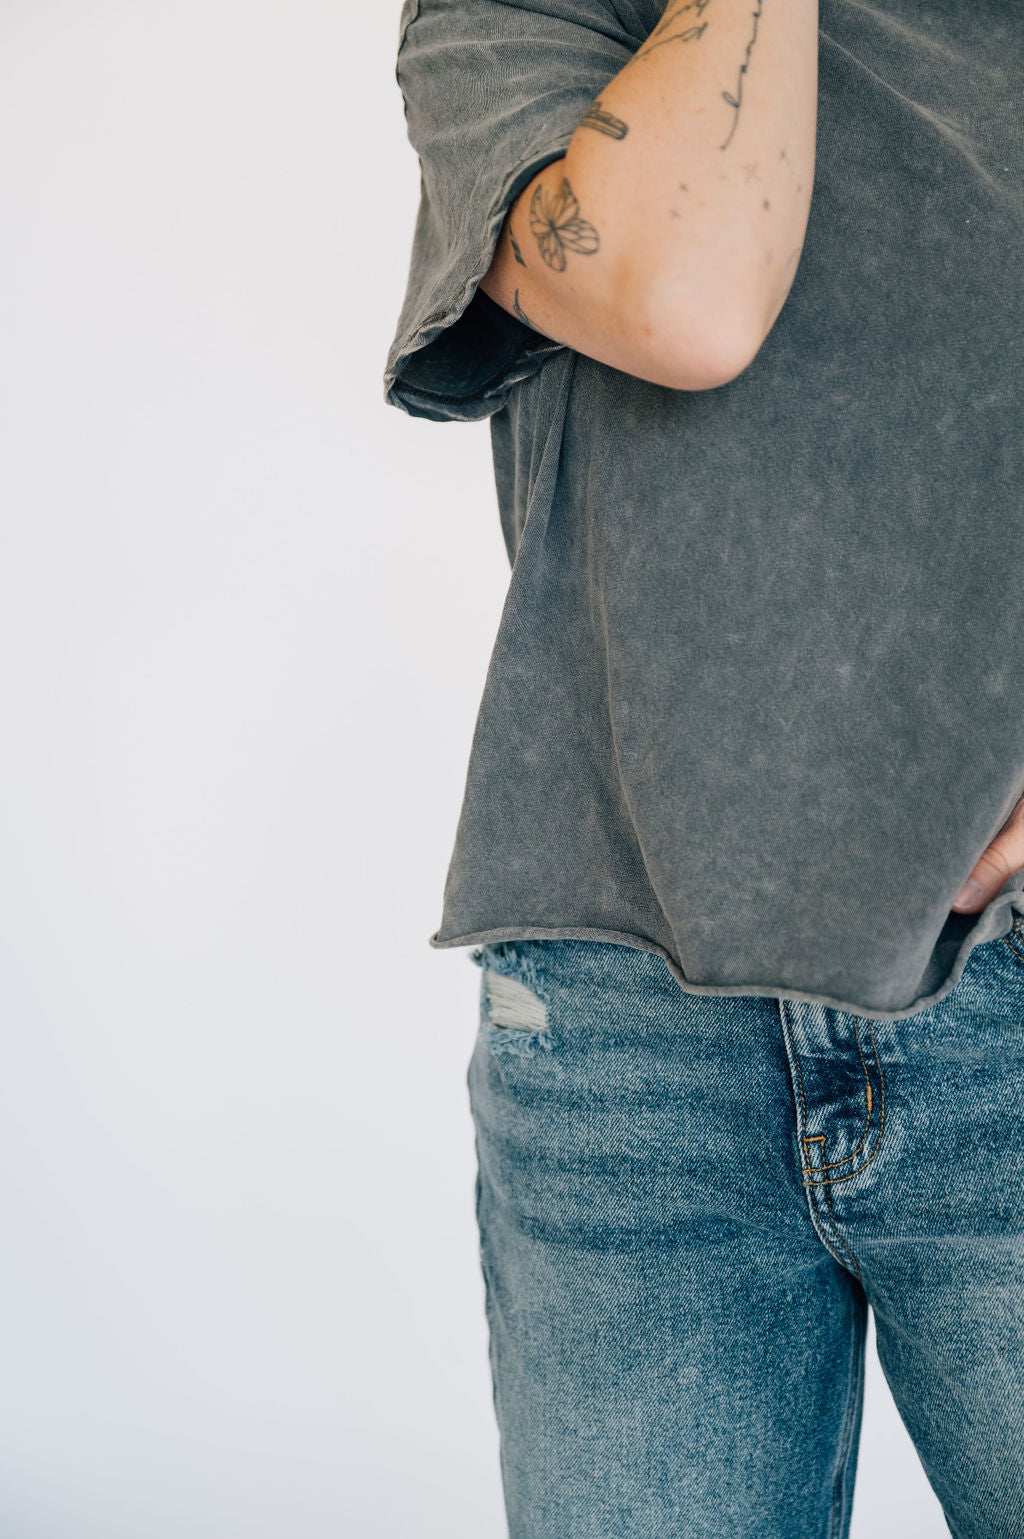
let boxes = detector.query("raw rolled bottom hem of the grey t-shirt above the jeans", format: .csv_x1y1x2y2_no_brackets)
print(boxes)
428,888,1024,1020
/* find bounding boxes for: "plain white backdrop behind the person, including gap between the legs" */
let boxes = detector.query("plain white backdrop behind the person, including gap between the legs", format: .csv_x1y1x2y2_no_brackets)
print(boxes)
0,0,947,1539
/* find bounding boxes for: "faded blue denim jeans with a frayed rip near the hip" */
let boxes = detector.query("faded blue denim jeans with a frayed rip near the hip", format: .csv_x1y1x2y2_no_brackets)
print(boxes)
467,916,1024,1539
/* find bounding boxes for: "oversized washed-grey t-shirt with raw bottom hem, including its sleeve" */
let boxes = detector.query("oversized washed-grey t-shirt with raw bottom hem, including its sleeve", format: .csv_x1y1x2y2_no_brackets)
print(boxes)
383,0,1024,1019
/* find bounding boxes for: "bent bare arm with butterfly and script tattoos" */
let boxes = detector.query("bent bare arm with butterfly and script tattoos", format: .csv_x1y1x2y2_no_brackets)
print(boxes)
480,0,818,389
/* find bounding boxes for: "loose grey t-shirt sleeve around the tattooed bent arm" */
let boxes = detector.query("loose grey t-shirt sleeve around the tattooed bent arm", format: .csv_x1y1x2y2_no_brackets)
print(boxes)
383,0,639,422
